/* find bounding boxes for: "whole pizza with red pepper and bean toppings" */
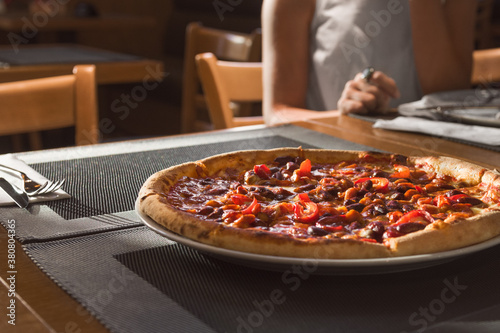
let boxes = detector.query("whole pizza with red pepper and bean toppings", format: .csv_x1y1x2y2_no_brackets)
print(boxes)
137,147,500,259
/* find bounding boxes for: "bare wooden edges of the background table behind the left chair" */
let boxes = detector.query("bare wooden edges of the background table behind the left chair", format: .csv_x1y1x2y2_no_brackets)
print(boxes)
0,44,163,84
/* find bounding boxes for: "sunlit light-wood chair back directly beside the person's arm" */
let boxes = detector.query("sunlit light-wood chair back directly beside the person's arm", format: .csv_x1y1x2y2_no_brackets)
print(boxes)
196,52,264,129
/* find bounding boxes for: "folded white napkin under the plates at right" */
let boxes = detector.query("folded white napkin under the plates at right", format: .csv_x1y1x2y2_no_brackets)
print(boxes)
373,117,500,146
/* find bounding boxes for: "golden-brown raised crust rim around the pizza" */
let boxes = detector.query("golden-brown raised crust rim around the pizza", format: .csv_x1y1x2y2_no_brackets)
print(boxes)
138,148,500,259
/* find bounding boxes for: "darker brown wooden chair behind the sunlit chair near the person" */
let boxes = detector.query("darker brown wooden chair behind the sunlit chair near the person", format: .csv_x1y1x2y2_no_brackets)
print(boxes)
182,22,262,133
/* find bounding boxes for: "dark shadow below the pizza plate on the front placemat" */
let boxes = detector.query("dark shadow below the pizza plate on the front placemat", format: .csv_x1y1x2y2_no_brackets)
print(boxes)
115,244,500,332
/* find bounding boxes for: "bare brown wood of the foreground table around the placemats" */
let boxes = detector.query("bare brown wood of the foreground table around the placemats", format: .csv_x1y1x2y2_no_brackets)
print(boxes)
0,116,500,332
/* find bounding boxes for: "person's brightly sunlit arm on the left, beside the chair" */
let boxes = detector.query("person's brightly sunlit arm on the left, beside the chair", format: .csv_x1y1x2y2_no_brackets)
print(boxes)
262,0,336,124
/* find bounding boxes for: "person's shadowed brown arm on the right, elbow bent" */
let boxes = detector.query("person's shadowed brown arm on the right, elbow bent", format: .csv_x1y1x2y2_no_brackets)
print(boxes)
410,0,477,94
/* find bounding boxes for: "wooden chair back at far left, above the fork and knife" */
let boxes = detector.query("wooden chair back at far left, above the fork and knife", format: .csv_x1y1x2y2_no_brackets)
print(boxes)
0,65,99,149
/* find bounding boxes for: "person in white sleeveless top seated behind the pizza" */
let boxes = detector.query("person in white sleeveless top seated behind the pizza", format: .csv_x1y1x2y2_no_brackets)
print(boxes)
262,0,477,124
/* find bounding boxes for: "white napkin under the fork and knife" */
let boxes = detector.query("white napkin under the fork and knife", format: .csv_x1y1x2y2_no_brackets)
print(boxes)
0,154,71,206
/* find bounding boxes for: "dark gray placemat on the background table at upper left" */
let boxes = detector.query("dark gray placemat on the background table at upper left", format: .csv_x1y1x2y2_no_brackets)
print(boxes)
0,45,141,66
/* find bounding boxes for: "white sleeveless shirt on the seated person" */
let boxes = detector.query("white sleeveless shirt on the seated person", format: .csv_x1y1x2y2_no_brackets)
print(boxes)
306,0,421,111
